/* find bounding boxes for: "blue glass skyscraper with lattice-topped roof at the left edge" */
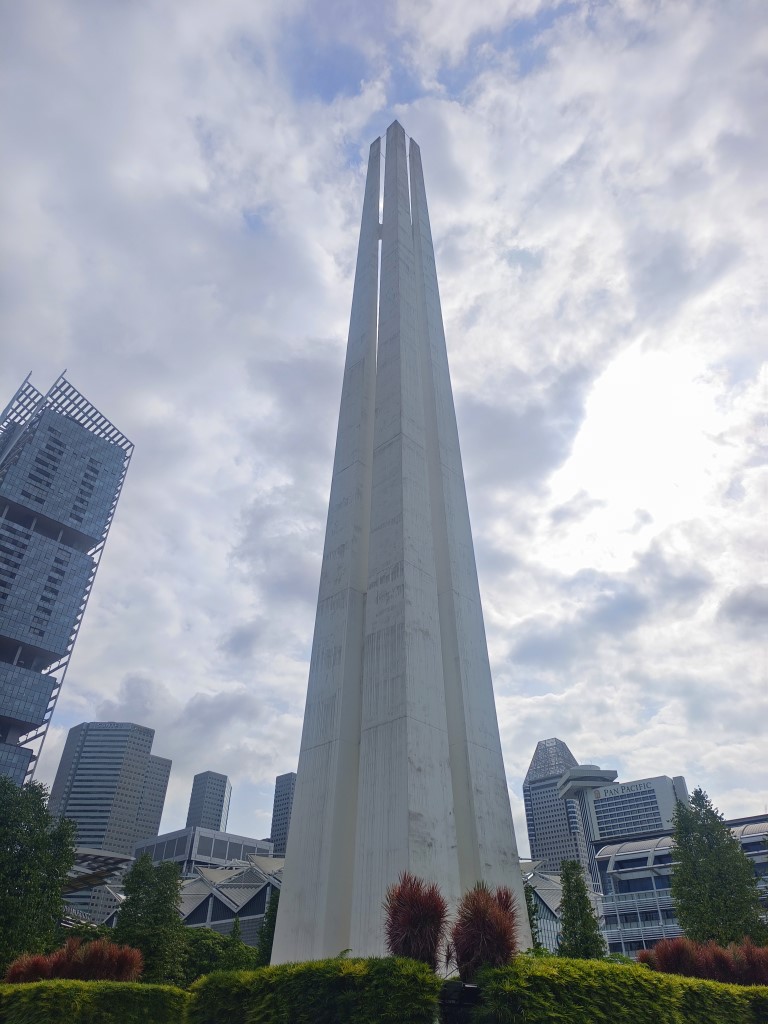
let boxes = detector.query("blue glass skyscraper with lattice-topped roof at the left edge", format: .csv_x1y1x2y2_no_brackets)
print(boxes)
0,376,133,785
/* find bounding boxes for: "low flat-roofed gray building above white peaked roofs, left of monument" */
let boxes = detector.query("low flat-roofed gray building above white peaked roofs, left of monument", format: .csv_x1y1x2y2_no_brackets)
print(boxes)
135,825,272,876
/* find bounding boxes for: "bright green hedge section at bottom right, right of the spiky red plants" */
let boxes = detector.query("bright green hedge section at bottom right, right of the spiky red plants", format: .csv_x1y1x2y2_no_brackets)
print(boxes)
472,955,768,1024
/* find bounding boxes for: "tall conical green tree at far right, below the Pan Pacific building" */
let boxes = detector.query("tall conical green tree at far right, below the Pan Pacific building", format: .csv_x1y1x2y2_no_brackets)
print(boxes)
672,788,768,946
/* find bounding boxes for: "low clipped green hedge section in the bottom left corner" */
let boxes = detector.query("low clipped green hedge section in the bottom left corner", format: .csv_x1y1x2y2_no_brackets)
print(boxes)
0,981,189,1024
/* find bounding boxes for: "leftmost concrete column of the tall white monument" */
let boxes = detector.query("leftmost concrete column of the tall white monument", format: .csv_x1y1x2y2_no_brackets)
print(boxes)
272,139,381,963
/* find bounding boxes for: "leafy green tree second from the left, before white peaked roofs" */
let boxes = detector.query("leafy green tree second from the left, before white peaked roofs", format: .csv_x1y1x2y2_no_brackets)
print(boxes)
115,854,185,984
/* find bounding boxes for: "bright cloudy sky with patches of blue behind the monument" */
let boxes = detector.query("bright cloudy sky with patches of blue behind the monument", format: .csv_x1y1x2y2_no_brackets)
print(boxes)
0,0,768,852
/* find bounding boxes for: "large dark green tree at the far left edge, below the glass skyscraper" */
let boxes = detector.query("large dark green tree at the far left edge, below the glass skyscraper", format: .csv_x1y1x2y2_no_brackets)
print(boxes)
0,775,76,976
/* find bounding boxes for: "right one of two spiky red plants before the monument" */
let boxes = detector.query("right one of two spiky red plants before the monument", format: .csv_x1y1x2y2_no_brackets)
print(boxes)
451,882,517,983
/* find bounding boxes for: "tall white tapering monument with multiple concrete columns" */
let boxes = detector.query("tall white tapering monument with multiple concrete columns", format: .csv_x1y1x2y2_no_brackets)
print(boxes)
272,121,530,963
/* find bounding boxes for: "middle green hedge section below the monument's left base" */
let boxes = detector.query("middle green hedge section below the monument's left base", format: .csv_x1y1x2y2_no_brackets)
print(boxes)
189,957,440,1024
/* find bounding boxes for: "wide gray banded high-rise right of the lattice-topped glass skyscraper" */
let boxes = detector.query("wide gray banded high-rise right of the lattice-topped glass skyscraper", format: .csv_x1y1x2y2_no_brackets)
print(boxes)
48,722,171,856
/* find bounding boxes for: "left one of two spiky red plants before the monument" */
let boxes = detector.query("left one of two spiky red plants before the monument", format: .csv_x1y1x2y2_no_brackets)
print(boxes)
384,871,447,971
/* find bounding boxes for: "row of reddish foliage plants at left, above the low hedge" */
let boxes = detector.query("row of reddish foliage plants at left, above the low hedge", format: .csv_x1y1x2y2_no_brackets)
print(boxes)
5,939,144,984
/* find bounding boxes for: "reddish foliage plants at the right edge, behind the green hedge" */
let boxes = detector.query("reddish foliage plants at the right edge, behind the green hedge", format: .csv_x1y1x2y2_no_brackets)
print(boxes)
637,936,768,985
